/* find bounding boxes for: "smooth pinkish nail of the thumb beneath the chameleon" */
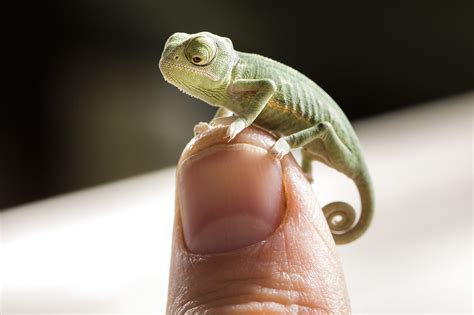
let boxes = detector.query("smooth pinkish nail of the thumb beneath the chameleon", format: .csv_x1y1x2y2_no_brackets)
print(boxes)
178,144,285,254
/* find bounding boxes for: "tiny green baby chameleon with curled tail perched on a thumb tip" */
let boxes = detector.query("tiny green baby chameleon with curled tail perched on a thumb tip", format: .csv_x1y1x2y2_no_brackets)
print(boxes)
159,32,374,244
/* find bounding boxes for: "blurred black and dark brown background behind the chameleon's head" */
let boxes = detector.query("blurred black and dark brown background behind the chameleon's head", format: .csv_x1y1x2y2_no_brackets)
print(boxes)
4,1,474,209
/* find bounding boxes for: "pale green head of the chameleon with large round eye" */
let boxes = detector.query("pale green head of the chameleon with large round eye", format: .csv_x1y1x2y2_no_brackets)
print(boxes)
159,32,238,98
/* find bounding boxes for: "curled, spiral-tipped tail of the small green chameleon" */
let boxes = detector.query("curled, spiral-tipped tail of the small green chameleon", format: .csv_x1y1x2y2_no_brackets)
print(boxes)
323,170,374,245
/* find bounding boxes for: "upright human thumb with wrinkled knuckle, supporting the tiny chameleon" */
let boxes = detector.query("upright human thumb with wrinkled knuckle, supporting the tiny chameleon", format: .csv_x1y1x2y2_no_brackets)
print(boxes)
167,118,350,314
